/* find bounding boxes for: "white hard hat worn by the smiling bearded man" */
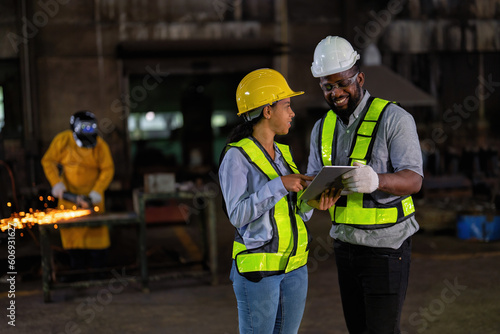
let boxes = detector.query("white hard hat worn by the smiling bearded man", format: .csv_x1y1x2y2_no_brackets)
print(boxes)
311,36,360,78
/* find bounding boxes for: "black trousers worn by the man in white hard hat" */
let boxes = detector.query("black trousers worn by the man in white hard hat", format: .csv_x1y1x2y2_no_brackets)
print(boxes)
333,238,411,334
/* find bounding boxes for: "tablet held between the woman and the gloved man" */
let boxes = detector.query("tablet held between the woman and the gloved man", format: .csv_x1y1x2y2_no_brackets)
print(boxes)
299,166,359,202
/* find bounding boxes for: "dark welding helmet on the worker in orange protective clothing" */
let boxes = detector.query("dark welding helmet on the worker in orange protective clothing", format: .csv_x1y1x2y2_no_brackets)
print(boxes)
69,110,97,148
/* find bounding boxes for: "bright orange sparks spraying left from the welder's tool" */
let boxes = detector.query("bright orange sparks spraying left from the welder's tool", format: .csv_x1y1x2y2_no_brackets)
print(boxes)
0,210,91,232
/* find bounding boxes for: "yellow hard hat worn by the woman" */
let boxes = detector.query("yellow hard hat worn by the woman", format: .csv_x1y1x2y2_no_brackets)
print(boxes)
236,68,304,116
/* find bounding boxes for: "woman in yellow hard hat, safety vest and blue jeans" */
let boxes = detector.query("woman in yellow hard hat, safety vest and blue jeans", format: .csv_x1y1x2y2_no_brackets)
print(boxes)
219,69,338,334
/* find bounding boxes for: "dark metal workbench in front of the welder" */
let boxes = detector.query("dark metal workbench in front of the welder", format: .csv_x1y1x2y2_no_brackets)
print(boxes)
38,192,217,302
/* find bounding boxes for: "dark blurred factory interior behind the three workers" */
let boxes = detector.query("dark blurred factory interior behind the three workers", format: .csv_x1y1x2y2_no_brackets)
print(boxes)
0,0,500,334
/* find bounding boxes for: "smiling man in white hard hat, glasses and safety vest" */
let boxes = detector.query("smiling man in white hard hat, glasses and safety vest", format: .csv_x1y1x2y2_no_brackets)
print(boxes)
307,36,423,334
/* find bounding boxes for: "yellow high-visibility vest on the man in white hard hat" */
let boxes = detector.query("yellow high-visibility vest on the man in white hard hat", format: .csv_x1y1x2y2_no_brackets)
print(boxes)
319,98,415,229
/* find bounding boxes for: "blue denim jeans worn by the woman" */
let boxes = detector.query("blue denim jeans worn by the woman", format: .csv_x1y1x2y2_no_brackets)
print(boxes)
230,261,307,334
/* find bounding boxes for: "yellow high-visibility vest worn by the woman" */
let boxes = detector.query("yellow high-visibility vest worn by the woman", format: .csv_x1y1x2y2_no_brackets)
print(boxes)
227,138,309,281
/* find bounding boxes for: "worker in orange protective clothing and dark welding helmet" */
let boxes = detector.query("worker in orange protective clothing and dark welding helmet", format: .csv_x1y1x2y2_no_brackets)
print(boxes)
42,110,115,280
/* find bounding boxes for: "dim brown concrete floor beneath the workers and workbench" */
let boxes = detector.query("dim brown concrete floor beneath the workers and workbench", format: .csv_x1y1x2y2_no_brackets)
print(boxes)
0,194,500,334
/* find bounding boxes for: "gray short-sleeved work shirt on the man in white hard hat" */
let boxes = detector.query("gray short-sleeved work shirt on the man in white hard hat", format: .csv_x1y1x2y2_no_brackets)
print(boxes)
307,90,424,249
